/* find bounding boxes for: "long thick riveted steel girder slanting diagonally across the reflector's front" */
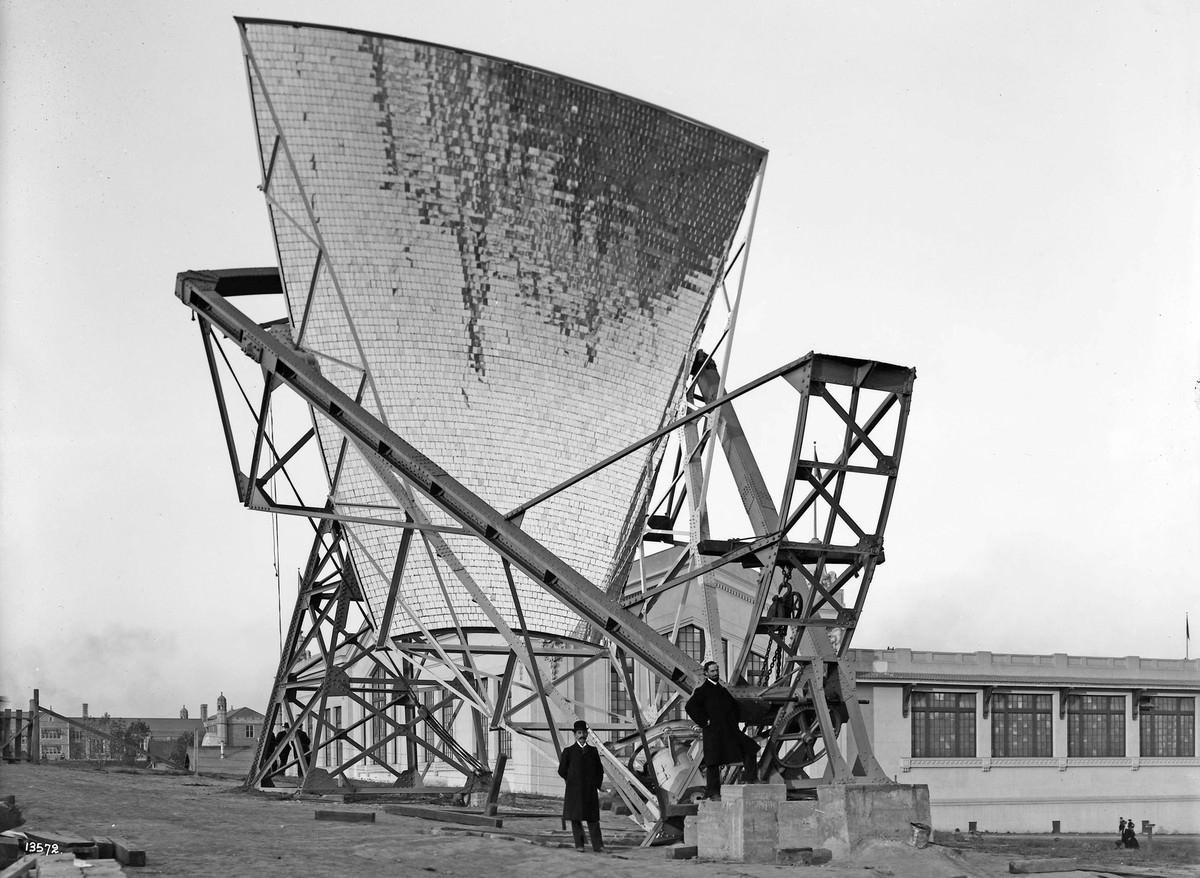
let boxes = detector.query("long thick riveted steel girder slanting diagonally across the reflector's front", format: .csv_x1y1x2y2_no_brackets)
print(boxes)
175,271,702,693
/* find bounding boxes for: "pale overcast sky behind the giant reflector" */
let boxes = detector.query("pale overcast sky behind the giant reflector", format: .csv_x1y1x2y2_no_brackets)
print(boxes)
0,0,1200,716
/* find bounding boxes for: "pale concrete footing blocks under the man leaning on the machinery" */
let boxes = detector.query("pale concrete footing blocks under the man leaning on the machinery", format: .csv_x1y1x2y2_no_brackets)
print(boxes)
684,783,929,862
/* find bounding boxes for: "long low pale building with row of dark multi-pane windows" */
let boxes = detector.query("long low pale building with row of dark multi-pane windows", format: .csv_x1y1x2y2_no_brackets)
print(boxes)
850,649,1200,832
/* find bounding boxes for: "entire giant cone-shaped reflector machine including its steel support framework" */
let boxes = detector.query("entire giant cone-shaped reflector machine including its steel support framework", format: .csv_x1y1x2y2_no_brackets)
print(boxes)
175,19,916,840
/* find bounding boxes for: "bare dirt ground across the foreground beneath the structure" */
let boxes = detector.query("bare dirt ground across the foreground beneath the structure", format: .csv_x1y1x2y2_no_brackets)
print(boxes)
0,763,1200,878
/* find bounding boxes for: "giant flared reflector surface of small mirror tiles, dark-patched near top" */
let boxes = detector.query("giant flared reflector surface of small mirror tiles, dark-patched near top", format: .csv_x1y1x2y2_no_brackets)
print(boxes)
242,22,766,636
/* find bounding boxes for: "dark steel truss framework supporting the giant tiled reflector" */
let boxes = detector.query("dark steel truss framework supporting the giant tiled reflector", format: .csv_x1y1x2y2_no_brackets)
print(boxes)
176,269,914,840
